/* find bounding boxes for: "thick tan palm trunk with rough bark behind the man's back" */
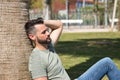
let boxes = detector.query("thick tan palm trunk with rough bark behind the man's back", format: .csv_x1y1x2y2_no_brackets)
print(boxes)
0,0,32,80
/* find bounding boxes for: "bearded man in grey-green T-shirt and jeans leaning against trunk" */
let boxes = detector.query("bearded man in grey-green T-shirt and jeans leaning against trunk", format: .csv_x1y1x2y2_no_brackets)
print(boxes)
25,18,120,80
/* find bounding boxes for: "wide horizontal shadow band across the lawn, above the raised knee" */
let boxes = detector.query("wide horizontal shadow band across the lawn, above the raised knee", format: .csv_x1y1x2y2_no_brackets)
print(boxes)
56,39,120,59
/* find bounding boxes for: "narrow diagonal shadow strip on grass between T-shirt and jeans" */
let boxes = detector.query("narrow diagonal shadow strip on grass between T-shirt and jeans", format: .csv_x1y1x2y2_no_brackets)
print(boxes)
66,57,101,80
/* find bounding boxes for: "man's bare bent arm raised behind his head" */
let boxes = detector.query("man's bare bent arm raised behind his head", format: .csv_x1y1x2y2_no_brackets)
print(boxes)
44,20,63,45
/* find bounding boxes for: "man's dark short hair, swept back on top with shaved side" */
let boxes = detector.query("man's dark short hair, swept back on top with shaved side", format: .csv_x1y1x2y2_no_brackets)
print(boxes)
24,18,44,36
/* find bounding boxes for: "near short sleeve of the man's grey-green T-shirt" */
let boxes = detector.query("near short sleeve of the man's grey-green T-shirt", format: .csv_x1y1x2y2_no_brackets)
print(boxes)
29,54,47,79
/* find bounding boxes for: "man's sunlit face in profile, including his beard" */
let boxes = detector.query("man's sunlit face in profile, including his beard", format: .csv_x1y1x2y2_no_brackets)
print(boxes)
35,24,51,44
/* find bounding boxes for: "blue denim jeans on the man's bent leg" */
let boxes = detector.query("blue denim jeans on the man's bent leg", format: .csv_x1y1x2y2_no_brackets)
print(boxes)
76,57,120,80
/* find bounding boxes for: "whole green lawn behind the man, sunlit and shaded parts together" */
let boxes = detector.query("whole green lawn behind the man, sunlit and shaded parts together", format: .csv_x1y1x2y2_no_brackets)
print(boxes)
56,32,120,80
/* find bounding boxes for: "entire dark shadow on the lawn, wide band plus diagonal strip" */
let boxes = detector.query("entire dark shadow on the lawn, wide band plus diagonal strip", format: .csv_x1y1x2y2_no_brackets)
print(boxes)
56,38,120,80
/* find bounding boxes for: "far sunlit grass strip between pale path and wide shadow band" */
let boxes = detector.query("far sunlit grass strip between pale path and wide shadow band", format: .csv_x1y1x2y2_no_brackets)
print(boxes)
60,32,120,41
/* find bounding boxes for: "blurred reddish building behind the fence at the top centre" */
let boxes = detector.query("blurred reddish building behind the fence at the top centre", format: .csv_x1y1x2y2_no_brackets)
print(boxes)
52,0,93,13
